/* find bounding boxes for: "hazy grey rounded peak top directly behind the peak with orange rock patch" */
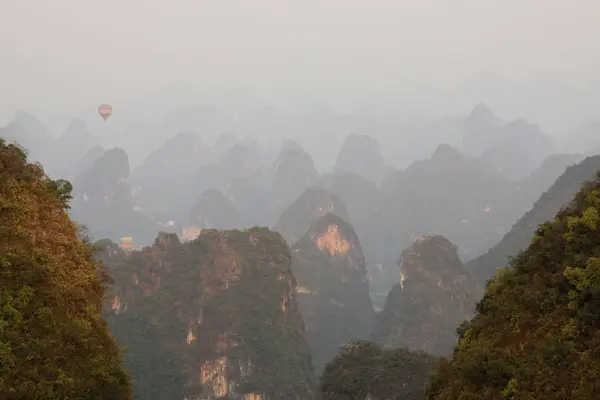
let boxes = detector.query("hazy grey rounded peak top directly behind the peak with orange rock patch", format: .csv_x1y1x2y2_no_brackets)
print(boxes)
273,188,349,246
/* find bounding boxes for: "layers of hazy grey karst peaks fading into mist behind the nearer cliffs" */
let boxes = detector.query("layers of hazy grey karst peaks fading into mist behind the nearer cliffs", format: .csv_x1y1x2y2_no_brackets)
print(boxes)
1,103,600,312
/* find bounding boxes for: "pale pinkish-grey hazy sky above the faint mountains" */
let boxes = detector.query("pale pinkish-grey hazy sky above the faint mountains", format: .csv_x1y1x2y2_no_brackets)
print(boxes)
0,0,600,131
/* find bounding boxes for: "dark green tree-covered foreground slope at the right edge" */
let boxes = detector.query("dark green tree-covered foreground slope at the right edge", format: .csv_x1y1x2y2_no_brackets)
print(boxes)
427,173,600,400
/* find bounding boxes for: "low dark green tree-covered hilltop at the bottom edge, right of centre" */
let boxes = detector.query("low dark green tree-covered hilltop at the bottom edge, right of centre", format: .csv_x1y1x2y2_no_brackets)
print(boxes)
321,341,435,400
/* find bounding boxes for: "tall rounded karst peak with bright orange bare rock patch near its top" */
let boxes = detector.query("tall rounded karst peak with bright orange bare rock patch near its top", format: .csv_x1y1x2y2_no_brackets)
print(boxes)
292,214,374,371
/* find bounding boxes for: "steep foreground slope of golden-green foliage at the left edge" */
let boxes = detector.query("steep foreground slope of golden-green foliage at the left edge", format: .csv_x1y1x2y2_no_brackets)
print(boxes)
0,139,131,400
